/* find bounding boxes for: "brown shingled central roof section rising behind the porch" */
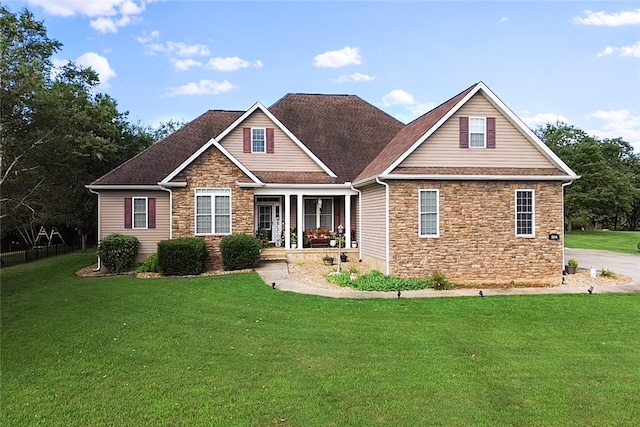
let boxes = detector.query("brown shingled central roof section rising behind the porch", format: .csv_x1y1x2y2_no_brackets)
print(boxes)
269,93,404,182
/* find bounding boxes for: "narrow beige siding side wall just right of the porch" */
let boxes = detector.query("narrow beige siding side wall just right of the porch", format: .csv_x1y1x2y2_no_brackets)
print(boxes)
360,184,386,260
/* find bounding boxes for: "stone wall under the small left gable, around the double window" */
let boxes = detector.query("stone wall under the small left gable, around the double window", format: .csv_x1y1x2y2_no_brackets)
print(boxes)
173,147,254,270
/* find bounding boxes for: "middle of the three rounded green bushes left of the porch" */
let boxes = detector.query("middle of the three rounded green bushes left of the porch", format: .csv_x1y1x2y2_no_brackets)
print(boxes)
158,237,208,276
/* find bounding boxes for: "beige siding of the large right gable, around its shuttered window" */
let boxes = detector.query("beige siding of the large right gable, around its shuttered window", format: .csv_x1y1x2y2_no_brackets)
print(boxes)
399,93,555,168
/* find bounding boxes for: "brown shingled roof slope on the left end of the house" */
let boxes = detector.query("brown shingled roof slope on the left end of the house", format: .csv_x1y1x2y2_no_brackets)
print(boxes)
90,110,243,187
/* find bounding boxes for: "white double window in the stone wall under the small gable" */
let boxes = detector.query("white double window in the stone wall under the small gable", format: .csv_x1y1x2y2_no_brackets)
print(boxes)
196,188,231,235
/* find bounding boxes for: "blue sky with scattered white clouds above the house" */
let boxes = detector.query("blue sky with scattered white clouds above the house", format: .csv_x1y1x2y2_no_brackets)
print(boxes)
5,0,640,152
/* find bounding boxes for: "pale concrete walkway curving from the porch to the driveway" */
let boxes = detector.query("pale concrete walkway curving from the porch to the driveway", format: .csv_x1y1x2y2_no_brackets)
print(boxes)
256,250,640,299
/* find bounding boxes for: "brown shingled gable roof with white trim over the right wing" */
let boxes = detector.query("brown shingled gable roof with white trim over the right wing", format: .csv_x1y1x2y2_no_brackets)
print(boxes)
355,82,576,182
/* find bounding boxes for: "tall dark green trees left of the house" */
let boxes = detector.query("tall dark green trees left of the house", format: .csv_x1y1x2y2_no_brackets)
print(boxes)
0,5,182,251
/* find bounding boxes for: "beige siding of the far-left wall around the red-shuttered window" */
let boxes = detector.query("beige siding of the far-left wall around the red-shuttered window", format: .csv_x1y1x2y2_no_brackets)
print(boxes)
98,191,169,261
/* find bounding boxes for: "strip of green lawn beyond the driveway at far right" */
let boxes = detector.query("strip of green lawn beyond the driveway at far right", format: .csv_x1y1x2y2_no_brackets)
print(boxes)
565,231,640,254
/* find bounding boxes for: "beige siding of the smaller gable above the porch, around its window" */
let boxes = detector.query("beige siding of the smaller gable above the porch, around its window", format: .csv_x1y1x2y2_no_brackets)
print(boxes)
221,111,322,172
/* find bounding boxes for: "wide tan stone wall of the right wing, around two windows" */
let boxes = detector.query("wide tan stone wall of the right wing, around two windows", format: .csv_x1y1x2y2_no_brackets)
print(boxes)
389,181,563,284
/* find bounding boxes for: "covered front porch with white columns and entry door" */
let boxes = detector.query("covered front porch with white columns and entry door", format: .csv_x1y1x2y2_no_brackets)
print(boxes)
254,184,359,251
